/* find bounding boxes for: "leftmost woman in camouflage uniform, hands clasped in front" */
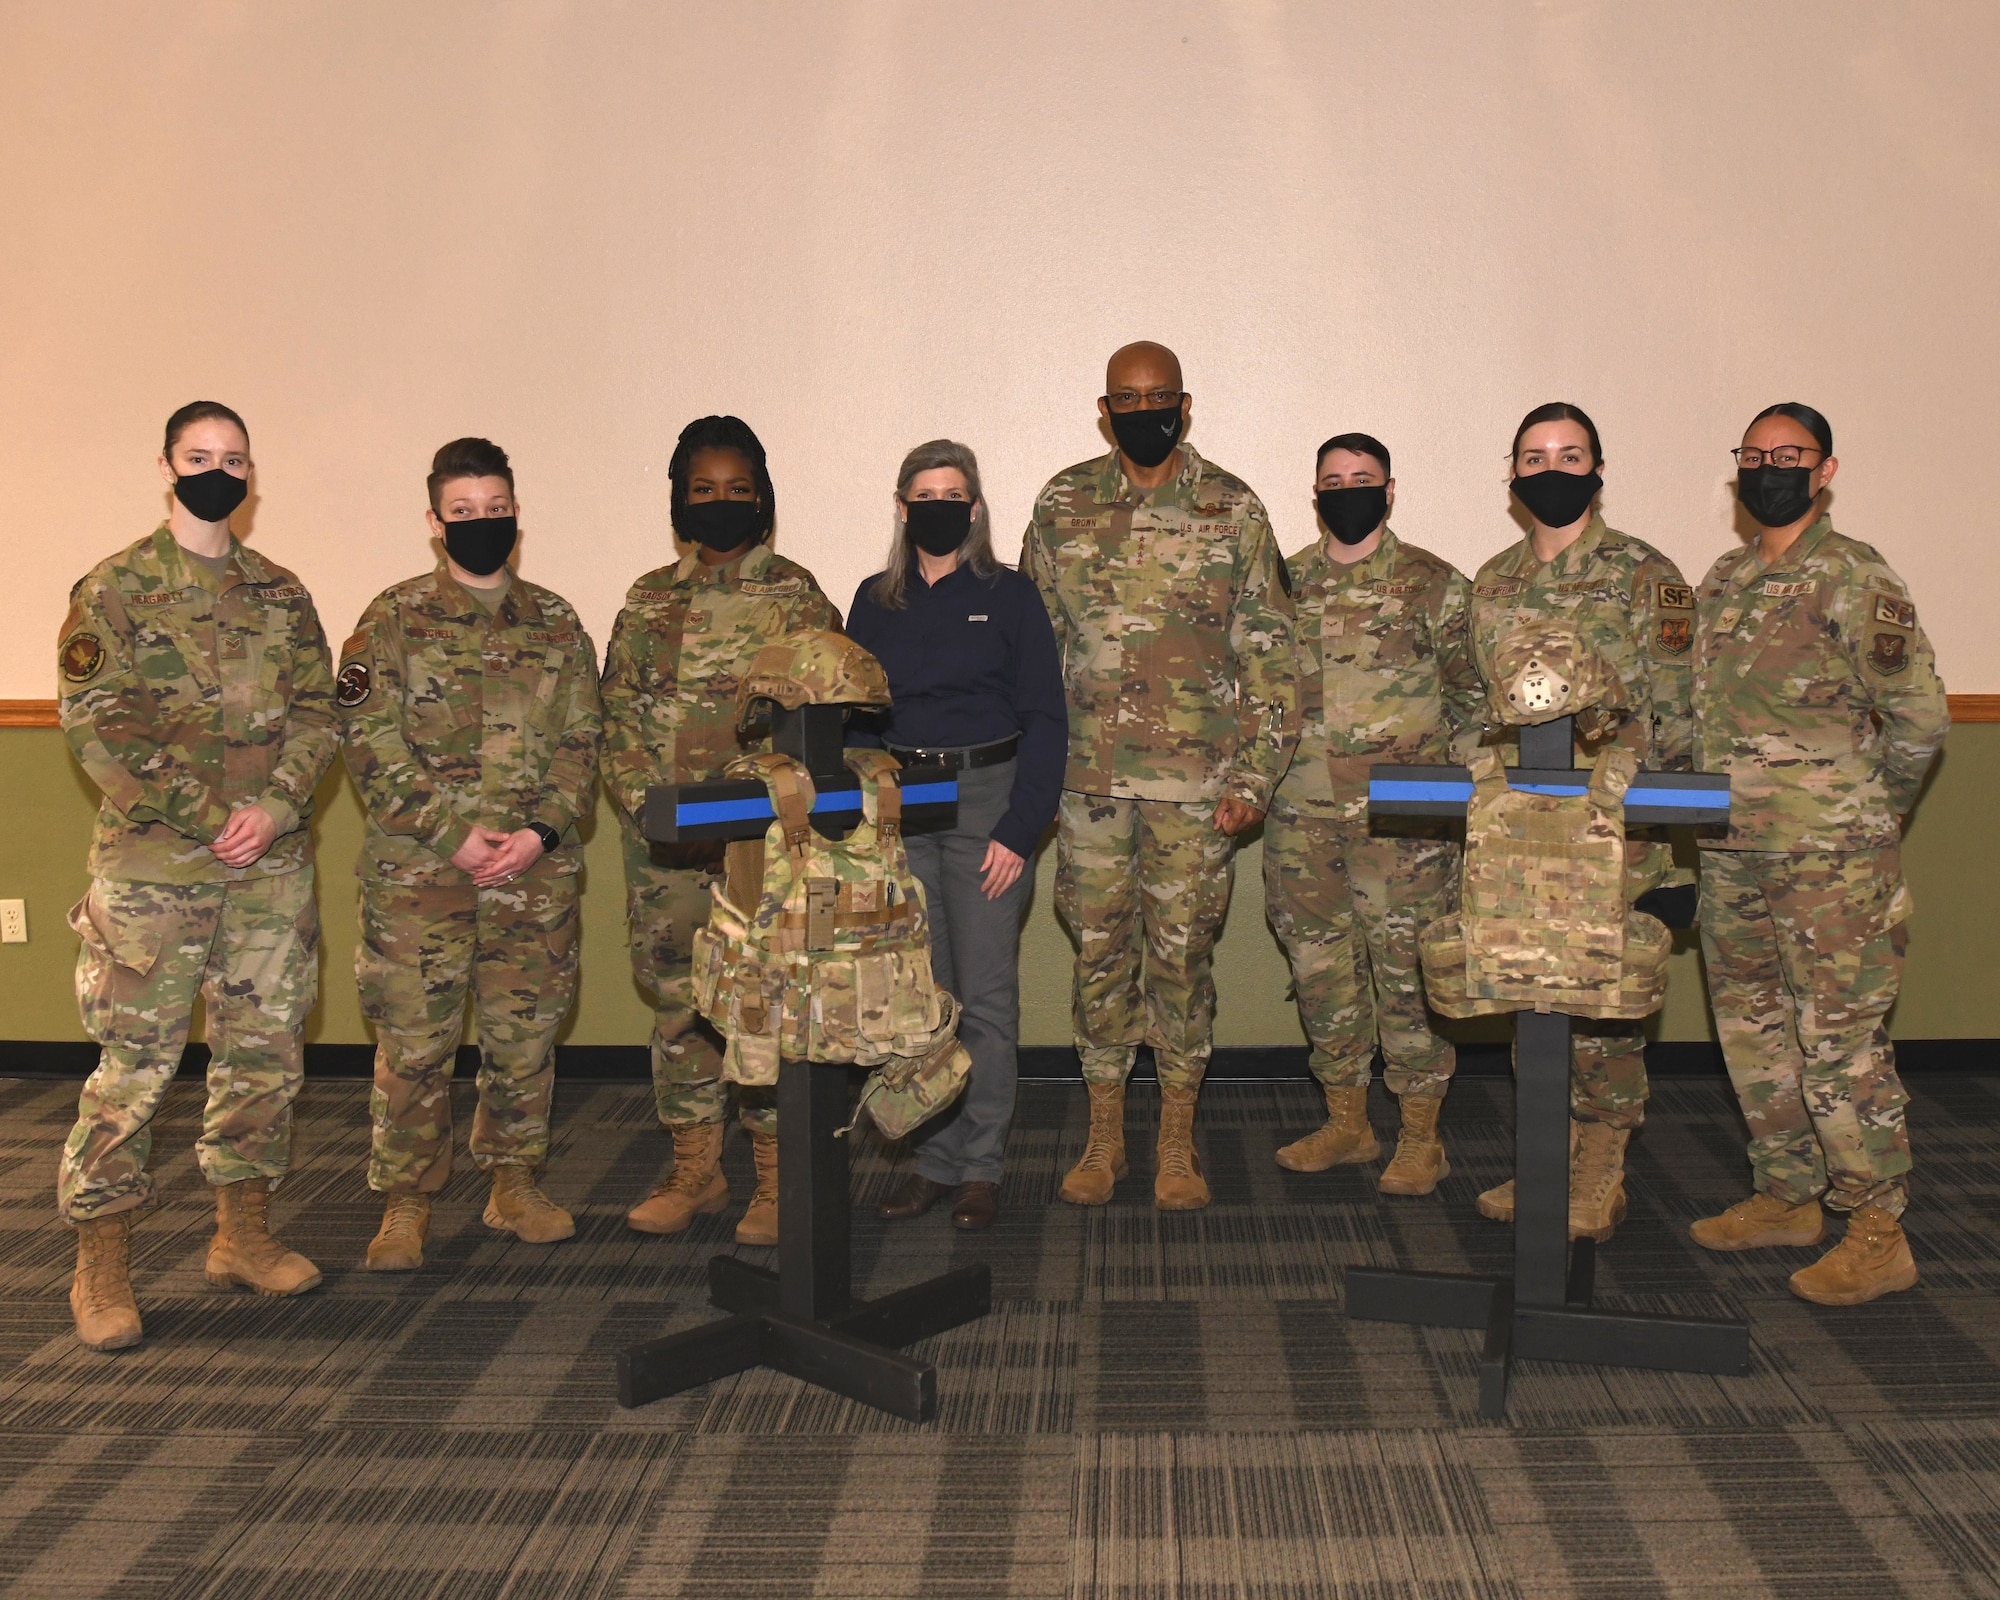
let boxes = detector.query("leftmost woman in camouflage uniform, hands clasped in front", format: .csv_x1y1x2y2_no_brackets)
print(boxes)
56,402,336,1350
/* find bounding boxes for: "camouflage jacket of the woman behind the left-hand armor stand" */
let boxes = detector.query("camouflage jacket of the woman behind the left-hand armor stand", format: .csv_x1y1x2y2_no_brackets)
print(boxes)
604,544,840,822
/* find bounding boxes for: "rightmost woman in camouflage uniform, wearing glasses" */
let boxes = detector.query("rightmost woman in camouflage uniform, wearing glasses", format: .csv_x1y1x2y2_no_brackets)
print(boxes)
1692,412,1948,1304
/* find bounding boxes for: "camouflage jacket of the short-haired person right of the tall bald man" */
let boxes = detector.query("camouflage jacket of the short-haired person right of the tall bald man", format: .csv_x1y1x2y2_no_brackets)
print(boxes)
1282,528,1486,822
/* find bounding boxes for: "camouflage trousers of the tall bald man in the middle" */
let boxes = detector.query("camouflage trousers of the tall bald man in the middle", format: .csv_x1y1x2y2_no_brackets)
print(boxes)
1056,790,1236,1088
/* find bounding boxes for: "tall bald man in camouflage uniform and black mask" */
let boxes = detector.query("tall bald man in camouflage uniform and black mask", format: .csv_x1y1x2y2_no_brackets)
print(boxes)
1020,344,1298,1210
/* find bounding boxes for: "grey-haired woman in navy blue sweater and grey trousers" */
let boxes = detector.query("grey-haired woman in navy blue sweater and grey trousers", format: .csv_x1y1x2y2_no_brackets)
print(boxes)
848,438,1070,1228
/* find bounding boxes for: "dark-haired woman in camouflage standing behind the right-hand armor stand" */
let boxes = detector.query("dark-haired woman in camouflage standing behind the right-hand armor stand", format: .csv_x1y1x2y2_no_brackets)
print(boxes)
1470,424,1694,1234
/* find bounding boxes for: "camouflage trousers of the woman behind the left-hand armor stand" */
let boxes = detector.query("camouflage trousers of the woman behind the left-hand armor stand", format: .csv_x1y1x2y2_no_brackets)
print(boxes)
626,846,778,1134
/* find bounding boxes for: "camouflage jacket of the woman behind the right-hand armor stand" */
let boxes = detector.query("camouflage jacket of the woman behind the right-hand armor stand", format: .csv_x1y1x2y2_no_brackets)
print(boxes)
1472,516,1694,772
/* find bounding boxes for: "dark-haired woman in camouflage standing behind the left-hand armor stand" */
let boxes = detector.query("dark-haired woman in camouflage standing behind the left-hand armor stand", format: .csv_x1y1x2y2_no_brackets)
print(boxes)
602,418,840,1244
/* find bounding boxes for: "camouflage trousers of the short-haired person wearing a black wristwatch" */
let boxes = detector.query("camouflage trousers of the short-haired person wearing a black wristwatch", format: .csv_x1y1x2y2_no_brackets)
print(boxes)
354,874,578,1194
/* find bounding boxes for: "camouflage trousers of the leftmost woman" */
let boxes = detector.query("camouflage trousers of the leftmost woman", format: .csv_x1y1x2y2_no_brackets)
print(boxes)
56,868,320,1222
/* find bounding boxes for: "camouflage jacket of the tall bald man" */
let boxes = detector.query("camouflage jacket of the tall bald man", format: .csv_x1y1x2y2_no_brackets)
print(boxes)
1020,444,1298,810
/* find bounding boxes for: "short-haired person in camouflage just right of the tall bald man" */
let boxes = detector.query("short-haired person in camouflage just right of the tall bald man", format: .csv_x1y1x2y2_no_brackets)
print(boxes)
1264,436,1484,1194
